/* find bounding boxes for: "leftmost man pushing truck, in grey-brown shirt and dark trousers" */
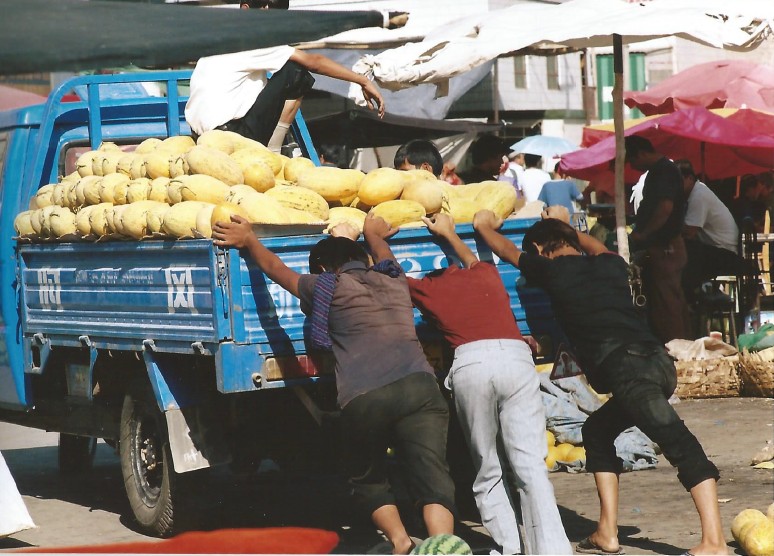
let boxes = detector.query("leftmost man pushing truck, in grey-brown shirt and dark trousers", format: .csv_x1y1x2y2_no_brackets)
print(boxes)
212,216,456,554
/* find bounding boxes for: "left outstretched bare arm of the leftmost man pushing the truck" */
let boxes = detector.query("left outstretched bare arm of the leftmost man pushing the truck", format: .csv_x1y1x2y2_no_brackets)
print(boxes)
212,215,300,297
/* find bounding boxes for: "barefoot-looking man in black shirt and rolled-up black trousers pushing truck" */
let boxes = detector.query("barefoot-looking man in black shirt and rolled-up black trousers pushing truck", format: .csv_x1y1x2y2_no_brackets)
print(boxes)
473,207,727,554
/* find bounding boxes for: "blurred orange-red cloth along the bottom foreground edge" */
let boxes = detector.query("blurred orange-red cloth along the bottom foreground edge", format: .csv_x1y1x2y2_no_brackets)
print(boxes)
14,527,339,554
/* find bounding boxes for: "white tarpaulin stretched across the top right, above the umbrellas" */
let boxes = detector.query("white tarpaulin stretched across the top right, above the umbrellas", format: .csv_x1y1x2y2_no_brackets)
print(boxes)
350,0,774,100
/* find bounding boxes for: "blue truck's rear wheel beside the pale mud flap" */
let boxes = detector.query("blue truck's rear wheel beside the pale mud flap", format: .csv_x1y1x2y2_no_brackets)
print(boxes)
119,384,175,537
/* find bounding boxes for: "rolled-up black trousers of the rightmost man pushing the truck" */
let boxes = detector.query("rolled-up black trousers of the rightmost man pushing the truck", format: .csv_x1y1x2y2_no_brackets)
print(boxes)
583,344,720,490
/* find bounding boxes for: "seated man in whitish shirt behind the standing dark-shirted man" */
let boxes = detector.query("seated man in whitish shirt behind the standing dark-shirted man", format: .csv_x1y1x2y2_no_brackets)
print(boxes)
675,156,744,301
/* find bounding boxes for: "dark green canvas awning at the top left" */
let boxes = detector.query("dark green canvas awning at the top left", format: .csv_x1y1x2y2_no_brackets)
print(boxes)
0,0,383,75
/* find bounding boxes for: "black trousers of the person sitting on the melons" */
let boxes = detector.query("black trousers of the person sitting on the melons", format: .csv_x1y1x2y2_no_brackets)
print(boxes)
218,62,314,145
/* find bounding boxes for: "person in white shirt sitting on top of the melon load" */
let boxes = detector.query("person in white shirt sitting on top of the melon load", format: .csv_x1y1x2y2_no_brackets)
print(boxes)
185,0,384,152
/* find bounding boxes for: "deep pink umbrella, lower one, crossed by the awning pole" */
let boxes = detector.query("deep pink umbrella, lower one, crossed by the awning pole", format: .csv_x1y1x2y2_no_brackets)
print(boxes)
560,108,774,179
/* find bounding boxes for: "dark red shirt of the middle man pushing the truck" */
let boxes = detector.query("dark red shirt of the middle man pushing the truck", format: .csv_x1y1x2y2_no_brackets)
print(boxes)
408,262,522,348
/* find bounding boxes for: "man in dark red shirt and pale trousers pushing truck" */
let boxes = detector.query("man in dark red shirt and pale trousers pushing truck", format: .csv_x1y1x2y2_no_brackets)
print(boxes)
368,214,573,554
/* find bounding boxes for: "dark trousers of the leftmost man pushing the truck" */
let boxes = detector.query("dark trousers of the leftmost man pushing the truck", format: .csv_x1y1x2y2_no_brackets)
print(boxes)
342,372,456,515
